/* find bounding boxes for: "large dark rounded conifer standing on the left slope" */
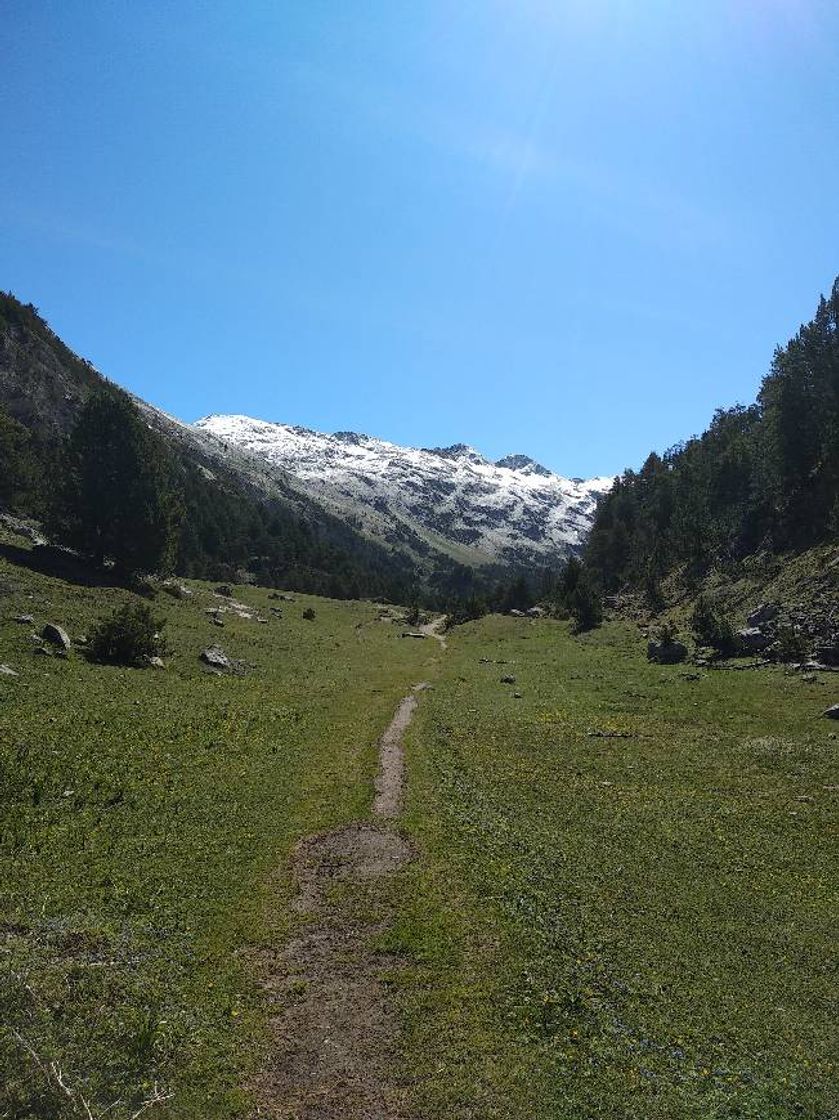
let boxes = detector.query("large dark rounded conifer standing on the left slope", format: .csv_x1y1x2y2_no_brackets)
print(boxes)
56,388,181,573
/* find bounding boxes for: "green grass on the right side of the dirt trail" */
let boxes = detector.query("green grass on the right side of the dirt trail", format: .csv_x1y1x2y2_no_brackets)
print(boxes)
394,617,839,1120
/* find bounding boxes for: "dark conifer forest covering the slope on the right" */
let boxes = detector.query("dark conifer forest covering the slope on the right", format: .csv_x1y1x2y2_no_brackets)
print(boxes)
586,281,839,591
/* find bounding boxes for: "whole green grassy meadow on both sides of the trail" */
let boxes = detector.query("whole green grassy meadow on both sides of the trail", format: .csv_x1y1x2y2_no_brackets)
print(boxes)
0,526,839,1120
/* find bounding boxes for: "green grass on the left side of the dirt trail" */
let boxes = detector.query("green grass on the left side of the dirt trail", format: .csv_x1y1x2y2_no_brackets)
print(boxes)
0,537,437,1120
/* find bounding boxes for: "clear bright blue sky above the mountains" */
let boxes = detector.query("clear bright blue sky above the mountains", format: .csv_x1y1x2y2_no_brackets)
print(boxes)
0,0,839,475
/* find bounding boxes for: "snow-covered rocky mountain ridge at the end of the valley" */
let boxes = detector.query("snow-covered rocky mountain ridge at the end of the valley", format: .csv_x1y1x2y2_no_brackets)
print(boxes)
194,416,613,564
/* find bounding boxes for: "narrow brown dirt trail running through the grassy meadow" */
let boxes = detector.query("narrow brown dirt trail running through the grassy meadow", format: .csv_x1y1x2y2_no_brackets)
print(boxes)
250,619,446,1120
